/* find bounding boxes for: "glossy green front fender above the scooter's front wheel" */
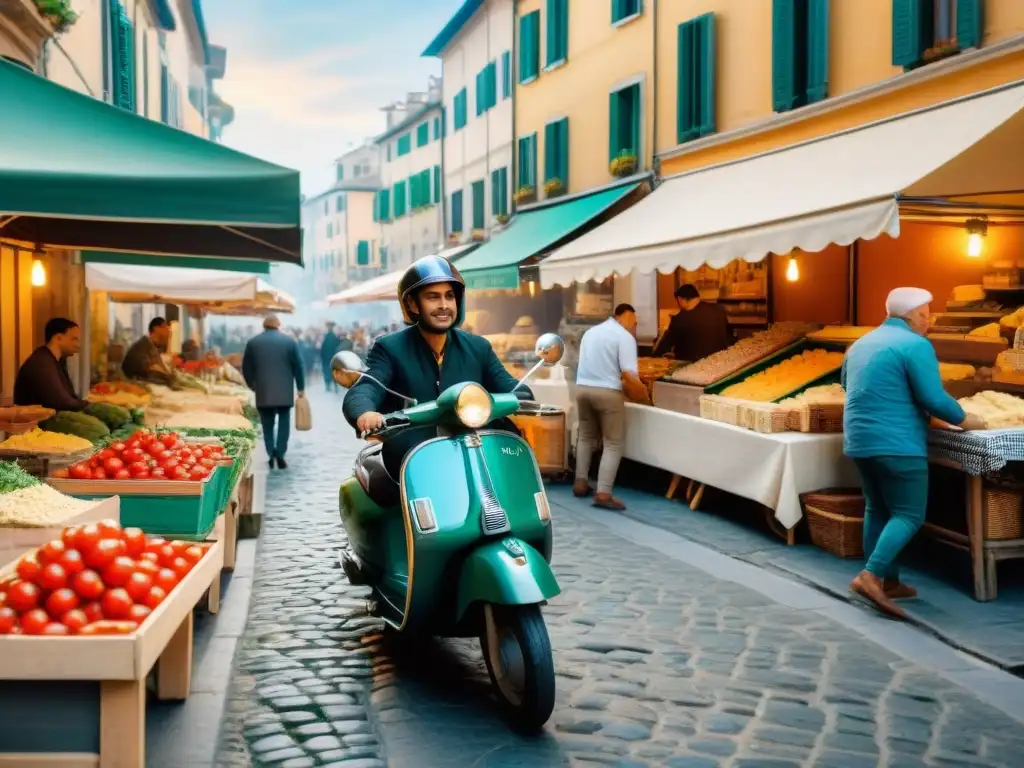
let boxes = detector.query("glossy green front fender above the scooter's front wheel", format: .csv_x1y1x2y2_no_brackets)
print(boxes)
456,537,561,623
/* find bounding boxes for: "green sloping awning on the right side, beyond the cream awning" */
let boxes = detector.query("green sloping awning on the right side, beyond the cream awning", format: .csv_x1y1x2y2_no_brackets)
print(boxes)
459,184,639,291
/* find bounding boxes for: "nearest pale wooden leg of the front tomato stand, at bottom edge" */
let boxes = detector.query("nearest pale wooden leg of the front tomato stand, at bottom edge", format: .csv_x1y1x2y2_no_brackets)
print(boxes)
99,680,145,768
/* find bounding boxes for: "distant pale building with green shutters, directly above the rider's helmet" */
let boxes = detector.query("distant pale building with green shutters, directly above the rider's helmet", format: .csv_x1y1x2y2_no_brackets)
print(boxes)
369,78,444,269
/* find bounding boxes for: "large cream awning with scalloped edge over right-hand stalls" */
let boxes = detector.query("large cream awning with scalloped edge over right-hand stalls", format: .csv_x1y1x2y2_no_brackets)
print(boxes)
541,83,1024,288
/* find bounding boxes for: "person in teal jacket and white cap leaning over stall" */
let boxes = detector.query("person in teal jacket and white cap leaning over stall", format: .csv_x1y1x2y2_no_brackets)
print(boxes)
843,288,985,618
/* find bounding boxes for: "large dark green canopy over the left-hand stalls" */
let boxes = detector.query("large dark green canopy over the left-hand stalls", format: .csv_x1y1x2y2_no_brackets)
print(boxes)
0,60,302,264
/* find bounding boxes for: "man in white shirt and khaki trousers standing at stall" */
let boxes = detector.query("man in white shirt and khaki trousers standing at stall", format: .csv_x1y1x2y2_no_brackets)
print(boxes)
572,304,646,510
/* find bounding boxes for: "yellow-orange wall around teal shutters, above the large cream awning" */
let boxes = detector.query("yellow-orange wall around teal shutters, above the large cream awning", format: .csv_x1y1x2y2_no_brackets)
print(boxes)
651,0,1024,176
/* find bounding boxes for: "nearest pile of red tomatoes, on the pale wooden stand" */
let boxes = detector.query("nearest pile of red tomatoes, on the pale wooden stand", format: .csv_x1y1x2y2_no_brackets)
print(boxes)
0,520,206,635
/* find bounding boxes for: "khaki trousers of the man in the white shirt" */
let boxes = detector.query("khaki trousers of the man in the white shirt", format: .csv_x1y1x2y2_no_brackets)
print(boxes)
575,386,626,494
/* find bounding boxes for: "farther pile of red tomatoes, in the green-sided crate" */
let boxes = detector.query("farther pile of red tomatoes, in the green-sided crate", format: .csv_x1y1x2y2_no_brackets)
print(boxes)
53,429,225,482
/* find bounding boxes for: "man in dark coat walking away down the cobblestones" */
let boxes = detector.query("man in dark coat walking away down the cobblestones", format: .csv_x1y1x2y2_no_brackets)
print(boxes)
242,314,306,469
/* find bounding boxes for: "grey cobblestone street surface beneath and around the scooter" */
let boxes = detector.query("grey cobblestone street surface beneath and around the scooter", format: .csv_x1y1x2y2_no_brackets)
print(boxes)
218,392,1024,768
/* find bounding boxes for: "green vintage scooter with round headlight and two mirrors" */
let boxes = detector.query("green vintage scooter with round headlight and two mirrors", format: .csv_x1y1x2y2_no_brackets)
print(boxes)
332,334,564,729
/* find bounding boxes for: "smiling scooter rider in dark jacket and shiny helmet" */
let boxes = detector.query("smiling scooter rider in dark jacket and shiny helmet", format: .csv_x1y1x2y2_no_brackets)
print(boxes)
343,256,534,480
